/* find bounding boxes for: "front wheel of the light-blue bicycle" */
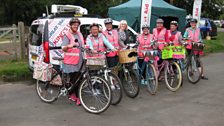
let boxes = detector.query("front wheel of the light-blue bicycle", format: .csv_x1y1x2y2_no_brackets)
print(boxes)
145,64,158,95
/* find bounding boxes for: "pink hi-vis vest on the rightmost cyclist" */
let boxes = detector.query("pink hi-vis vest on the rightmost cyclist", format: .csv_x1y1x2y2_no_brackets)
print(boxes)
186,28,200,49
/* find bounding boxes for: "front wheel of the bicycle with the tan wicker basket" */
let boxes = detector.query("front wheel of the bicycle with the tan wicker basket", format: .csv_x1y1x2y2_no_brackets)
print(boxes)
121,68,139,98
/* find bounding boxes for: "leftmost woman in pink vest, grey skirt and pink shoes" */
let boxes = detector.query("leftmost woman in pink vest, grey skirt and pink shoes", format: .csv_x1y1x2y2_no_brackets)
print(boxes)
62,18,84,105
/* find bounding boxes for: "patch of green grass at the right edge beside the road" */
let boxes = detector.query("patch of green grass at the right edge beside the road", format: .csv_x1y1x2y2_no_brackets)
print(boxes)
204,32,224,53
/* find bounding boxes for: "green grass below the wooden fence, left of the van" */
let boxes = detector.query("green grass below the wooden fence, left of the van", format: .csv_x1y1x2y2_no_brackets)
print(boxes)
0,61,32,81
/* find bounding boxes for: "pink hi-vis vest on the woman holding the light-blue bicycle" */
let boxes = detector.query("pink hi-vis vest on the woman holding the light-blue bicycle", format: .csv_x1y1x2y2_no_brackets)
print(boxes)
138,34,152,58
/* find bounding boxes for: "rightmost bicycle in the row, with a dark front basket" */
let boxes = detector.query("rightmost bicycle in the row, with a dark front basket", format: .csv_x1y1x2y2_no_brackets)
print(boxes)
178,42,205,84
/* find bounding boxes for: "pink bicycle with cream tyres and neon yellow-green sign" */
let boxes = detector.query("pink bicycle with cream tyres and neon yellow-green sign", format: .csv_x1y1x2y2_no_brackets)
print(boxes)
155,42,183,92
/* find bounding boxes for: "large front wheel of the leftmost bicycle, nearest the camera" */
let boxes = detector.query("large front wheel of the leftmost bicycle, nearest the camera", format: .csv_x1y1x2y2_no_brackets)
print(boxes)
79,76,111,114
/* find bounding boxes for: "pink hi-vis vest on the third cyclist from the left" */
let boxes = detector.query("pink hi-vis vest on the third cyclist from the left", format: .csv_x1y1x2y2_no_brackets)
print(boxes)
103,30,119,57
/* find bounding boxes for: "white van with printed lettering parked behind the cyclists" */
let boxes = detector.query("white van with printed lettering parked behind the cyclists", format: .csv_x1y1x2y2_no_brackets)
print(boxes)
29,5,137,70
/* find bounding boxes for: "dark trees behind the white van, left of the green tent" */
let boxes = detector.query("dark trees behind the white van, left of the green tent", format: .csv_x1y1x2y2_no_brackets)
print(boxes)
0,0,128,25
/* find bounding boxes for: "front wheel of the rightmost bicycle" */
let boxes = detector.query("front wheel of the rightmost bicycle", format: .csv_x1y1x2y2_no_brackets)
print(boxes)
187,56,203,84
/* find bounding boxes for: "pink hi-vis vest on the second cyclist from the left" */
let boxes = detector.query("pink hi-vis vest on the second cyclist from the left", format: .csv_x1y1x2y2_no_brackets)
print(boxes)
87,34,105,58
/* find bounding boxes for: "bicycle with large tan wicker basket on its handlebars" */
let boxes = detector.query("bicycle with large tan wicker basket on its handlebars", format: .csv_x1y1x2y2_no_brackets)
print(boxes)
113,45,140,98
